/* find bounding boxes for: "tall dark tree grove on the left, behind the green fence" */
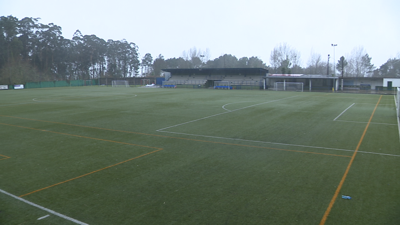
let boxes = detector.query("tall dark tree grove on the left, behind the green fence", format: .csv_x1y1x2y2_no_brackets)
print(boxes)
0,16,140,84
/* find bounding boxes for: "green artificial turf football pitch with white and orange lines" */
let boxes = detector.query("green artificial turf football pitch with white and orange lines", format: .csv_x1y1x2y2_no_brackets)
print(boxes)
0,87,400,225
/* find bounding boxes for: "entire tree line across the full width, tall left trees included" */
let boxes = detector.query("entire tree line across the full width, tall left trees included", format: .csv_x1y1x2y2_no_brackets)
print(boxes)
0,16,400,84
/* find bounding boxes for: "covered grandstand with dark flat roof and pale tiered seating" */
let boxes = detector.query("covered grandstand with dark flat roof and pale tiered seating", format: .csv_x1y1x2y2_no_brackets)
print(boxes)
163,68,268,89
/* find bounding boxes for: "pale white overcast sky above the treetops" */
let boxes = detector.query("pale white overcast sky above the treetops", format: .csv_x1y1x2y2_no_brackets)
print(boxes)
0,0,400,67
